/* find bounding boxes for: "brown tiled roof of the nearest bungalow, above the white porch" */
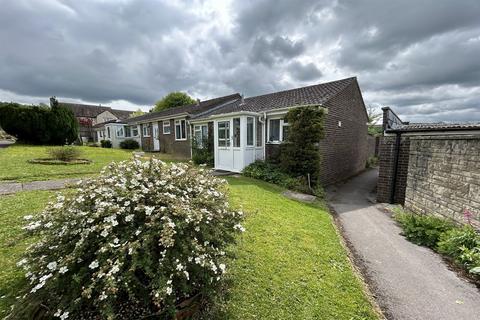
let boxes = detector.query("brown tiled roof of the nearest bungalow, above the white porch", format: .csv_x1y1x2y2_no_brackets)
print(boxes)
192,77,356,118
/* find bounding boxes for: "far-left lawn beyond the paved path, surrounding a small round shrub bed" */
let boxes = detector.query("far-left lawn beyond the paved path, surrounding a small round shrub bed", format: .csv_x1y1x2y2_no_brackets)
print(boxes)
0,145,132,181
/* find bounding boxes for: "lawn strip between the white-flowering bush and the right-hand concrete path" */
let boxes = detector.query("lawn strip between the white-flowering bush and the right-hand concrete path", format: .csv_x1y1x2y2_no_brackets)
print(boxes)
213,178,378,320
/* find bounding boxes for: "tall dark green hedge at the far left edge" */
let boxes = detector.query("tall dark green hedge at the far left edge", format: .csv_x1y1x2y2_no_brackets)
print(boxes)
0,98,78,145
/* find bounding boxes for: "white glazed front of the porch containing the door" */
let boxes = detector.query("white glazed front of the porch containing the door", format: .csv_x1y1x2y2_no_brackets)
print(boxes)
214,117,244,172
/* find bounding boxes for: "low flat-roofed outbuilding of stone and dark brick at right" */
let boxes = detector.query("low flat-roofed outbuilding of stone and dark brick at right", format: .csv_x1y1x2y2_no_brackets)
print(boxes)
377,107,480,227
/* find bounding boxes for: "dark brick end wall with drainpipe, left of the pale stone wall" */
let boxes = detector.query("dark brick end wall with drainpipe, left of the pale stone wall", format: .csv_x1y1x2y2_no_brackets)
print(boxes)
377,135,410,204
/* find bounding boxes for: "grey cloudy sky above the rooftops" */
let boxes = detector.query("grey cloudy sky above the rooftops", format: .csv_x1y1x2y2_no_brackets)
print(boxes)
0,0,480,121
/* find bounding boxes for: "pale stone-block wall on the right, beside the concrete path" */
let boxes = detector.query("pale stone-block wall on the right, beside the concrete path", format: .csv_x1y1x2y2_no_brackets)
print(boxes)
405,135,480,228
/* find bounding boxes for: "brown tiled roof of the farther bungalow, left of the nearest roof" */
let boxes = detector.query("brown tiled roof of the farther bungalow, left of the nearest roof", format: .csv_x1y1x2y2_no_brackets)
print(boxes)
128,93,240,123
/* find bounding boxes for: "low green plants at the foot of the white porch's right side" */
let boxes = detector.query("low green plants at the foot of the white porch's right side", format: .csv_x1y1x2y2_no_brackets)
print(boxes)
242,160,300,189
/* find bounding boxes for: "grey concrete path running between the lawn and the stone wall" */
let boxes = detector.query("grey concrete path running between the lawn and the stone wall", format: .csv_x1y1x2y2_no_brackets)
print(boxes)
329,170,480,320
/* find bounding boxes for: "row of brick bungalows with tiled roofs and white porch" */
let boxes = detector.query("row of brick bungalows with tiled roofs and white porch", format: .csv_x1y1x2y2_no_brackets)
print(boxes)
99,78,369,184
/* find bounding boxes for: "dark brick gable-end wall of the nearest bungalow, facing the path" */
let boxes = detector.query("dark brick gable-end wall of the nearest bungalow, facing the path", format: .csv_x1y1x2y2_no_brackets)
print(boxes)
319,81,368,185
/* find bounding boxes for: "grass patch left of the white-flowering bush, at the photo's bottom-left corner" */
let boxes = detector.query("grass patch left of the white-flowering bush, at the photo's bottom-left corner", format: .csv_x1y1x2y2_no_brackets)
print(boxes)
0,191,55,319
